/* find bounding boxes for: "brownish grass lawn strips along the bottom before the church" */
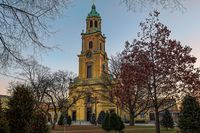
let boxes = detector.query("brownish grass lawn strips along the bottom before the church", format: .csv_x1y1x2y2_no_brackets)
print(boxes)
51,125,177,133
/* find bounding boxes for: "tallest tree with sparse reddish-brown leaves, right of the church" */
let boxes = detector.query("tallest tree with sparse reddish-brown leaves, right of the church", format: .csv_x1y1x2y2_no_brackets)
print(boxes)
117,11,200,133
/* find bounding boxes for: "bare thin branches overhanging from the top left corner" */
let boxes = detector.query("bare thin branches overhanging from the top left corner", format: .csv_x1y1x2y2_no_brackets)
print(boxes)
0,0,70,68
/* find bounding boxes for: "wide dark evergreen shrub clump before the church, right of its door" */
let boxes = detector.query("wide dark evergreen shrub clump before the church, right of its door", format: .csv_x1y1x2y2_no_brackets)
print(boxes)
102,112,125,132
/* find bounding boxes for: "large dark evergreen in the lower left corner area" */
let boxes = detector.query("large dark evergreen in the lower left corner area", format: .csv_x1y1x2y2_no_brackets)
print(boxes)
7,85,35,133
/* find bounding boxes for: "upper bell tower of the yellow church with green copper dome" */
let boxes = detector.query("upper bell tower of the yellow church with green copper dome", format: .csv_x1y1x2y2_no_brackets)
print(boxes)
78,4,108,80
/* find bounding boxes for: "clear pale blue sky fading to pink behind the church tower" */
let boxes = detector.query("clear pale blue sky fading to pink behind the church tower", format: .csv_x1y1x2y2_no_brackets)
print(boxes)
0,0,200,95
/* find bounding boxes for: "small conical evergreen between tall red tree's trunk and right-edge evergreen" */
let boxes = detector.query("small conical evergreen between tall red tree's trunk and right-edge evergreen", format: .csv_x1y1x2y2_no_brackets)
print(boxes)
161,110,174,130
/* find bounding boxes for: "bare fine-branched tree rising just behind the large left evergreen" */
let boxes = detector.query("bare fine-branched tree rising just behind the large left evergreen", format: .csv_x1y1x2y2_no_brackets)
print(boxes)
20,57,51,107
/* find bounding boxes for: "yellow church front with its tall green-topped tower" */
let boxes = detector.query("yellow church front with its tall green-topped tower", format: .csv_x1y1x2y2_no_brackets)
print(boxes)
68,4,125,121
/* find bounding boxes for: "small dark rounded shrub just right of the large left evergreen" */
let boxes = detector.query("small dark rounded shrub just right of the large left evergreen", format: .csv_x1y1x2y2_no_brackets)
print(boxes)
32,111,50,133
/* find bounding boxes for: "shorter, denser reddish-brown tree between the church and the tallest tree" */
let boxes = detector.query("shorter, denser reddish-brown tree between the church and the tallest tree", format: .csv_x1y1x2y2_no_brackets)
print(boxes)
111,47,149,126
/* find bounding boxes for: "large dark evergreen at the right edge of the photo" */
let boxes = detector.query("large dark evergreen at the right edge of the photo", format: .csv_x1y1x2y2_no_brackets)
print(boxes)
178,96,200,133
